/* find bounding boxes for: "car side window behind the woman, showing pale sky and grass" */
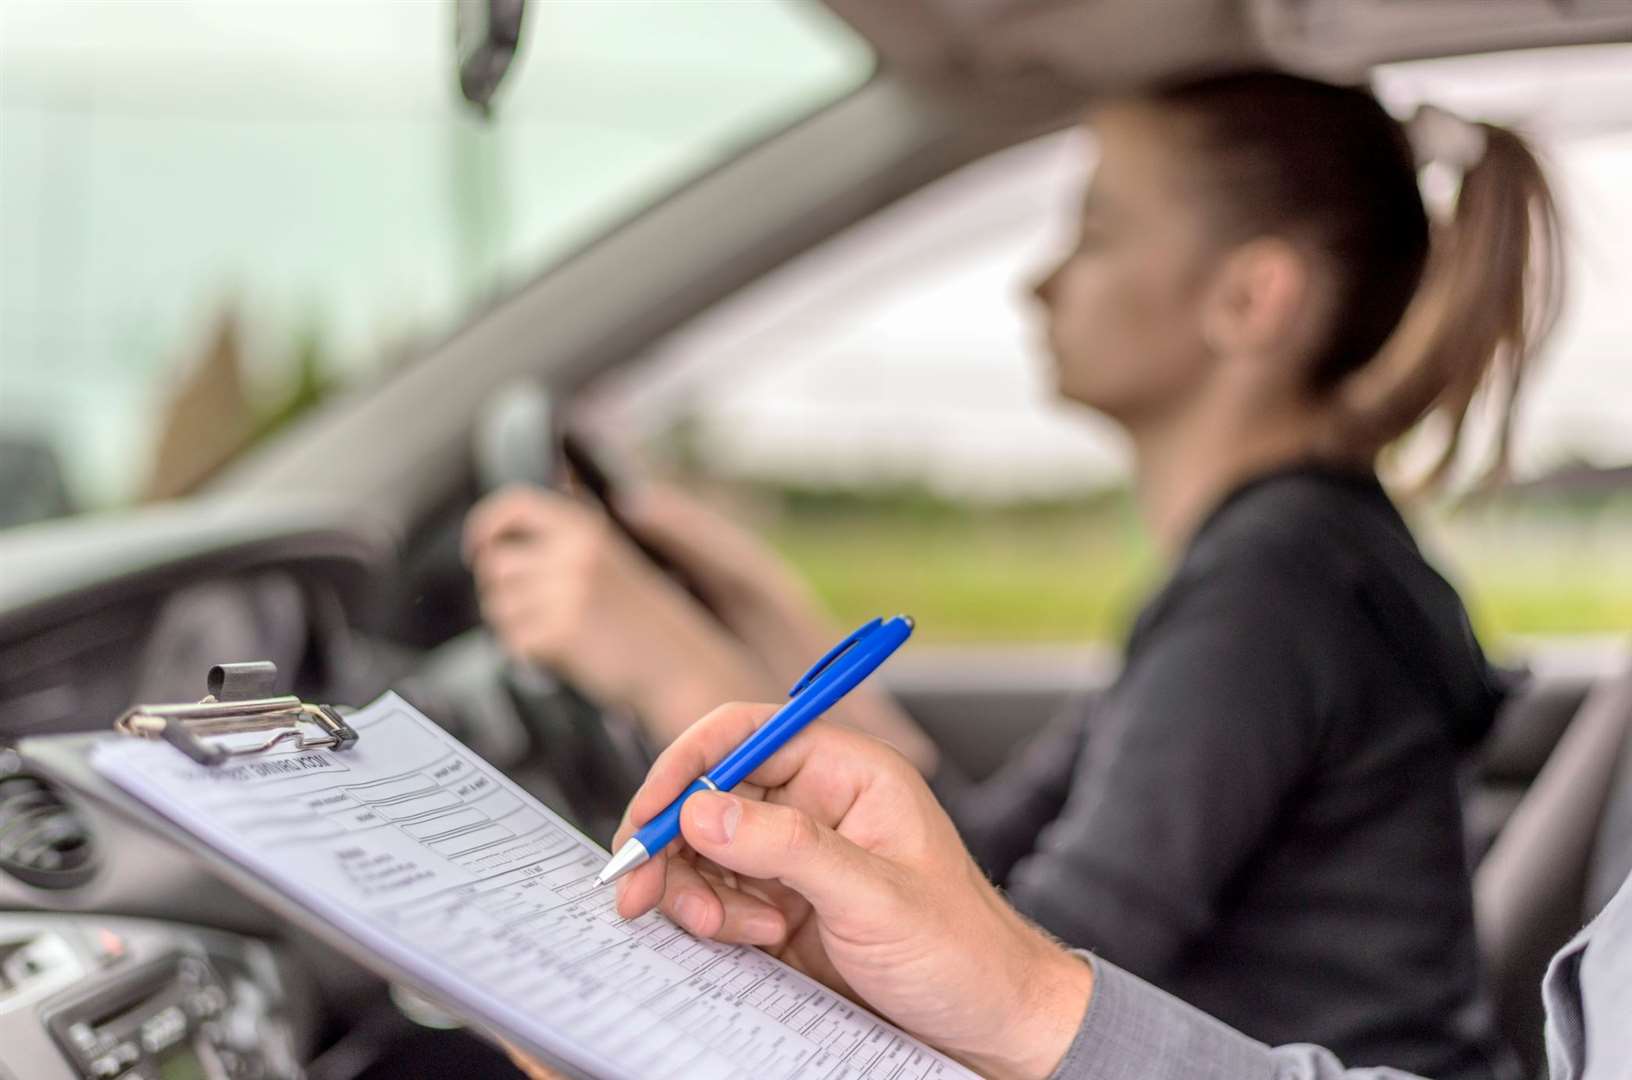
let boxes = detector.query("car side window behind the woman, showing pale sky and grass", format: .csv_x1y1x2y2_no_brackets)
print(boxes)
586,47,1632,652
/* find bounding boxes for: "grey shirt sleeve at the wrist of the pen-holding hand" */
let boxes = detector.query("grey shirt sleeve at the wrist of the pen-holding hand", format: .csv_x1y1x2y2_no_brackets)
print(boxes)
1053,954,1412,1080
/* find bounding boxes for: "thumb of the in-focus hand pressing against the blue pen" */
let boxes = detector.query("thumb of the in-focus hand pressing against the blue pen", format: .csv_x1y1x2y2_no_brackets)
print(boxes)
681,791,888,910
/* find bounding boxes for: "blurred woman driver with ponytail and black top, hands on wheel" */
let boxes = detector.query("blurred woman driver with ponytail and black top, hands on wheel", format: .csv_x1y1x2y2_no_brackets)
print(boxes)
467,73,1557,1078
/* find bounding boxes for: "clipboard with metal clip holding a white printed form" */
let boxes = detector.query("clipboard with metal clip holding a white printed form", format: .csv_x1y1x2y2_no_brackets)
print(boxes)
18,664,973,1080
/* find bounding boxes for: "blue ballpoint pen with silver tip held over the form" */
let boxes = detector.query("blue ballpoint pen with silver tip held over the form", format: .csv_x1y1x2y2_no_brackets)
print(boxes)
596,615,912,886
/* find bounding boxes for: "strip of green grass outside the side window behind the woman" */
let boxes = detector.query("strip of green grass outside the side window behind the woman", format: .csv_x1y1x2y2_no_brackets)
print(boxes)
769,501,1632,651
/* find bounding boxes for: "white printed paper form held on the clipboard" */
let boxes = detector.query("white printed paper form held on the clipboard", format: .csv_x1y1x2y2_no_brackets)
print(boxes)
91,693,973,1080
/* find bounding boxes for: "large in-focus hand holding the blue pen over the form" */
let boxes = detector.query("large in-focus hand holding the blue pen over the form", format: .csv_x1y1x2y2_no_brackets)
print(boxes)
614,705,1092,1077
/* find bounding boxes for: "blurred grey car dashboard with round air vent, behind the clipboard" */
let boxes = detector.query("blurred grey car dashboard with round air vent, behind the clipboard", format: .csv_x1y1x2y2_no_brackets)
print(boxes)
0,506,392,1080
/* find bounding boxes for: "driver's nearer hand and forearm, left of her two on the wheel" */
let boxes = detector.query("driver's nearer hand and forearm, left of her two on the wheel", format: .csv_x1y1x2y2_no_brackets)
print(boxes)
463,488,774,742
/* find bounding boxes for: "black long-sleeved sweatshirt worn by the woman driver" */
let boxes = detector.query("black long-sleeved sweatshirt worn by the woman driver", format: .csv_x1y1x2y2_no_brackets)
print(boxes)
937,467,1505,1080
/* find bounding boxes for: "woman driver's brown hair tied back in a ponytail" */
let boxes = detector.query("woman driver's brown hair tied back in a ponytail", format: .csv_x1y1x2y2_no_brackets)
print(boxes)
1146,72,1562,486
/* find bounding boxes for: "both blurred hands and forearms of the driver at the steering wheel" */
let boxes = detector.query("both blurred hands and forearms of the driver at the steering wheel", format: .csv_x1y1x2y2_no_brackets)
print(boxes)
463,488,937,772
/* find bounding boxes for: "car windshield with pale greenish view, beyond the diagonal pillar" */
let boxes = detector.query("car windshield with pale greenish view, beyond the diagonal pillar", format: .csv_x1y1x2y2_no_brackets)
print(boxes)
0,0,873,527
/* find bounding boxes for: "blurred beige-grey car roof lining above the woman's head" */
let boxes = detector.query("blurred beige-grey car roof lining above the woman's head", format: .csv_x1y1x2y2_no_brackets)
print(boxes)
824,0,1632,95
